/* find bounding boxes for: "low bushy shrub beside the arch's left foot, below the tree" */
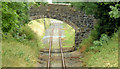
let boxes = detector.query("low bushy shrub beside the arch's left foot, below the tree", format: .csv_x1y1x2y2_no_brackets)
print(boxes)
11,25,37,41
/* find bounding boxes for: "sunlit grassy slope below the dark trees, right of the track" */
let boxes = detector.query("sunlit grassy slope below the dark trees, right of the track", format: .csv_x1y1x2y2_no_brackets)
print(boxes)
82,32,118,67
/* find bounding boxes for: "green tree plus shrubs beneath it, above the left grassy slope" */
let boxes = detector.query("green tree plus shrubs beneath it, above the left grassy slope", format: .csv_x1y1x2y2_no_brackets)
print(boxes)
2,2,34,41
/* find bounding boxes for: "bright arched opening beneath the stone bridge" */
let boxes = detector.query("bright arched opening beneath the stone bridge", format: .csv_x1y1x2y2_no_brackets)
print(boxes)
28,18,75,52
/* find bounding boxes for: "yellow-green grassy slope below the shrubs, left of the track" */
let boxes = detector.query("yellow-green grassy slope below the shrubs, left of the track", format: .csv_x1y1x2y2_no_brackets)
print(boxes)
2,34,39,67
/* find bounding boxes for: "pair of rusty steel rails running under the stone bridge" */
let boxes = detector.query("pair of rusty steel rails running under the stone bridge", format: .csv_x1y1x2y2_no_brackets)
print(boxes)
47,25,66,69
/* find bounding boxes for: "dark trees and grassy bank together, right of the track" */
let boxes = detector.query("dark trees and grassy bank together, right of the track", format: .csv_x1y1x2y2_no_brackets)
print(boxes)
72,2,120,67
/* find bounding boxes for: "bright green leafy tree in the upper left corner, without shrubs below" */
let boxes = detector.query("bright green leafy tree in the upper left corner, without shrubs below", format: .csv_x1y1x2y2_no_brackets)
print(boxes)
2,2,28,32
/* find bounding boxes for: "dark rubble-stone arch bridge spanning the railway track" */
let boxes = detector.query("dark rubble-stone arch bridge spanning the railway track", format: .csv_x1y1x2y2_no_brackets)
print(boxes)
30,4,94,49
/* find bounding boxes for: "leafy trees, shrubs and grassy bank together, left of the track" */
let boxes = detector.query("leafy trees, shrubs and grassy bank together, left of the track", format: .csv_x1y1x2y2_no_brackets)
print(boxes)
2,2,40,67
